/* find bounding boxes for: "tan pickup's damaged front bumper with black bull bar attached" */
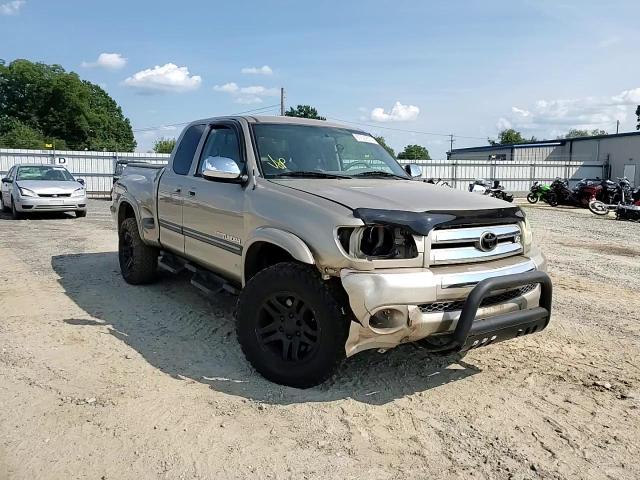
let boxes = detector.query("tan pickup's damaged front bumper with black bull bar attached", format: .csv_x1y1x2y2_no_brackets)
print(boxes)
341,254,551,356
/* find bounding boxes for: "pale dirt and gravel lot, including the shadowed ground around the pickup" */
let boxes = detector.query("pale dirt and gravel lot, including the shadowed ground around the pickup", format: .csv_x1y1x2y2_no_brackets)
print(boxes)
0,201,640,480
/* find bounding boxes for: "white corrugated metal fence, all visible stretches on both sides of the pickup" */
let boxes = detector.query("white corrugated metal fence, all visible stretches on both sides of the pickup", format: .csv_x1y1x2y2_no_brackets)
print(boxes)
0,149,609,196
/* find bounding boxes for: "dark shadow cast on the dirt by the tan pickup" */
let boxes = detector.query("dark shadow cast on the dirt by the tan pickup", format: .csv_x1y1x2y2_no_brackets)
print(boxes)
51,252,480,404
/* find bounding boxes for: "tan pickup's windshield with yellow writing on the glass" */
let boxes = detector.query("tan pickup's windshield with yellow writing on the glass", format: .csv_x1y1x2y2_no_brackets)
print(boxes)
253,124,408,178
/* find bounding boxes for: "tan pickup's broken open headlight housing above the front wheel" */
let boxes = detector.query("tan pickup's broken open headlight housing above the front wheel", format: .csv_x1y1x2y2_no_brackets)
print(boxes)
337,225,418,260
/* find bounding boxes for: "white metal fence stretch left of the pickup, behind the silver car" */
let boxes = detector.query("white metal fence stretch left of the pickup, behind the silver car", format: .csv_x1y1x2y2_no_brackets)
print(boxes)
0,148,169,197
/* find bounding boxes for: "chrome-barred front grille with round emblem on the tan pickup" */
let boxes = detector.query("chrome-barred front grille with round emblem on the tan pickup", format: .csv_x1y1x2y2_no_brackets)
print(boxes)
429,224,523,265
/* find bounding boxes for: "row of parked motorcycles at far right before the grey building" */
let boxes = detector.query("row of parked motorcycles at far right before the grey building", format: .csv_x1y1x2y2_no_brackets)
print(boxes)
527,178,640,221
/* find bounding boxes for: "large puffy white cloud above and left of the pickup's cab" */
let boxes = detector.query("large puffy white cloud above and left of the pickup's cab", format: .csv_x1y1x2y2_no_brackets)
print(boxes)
124,63,202,93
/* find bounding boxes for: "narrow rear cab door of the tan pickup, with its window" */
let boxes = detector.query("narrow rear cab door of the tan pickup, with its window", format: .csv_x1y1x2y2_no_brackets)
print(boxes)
158,124,206,254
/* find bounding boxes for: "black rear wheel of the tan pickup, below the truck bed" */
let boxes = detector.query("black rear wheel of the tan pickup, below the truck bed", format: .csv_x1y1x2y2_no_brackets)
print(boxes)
118,218,158,285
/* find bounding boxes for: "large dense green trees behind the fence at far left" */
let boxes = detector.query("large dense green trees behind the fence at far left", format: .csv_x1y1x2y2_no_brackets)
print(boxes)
0,60,136,151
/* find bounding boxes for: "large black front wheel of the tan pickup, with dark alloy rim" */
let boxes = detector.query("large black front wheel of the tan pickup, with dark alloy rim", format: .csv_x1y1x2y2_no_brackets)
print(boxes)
236,262,349,388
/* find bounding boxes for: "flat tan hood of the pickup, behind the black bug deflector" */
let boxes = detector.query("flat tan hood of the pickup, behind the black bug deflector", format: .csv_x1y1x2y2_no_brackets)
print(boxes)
271,178,513,212
